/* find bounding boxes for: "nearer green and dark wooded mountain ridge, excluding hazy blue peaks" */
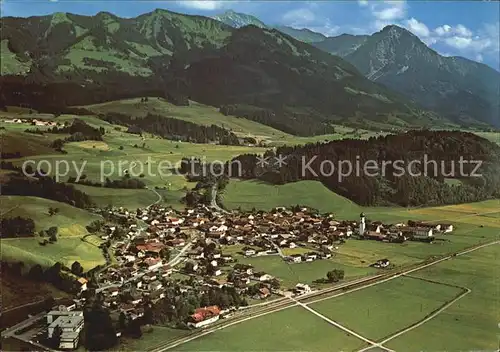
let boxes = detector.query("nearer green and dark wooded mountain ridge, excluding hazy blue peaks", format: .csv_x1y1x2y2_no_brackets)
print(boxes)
2,9,492,134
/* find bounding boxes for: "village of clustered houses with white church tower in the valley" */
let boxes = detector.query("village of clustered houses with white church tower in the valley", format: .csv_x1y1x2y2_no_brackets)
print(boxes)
9,205,453,349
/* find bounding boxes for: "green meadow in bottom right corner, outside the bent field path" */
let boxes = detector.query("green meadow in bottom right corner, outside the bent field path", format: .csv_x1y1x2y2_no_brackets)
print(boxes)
386,244,500,352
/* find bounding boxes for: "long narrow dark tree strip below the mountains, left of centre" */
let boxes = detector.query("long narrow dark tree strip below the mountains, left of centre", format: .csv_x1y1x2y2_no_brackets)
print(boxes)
99,113,239,145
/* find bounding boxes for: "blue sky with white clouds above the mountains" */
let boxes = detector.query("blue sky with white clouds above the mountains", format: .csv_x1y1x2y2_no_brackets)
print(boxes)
0,0,500,70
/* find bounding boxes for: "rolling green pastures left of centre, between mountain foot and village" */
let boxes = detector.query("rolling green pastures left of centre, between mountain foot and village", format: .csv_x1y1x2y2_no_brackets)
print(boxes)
0,113,265,208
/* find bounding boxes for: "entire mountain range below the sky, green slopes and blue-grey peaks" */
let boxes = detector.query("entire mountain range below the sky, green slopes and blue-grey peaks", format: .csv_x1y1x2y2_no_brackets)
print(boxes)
0,10,499,134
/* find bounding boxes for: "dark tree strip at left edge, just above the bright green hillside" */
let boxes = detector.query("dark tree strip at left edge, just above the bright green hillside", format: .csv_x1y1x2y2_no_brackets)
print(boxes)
2,175,93,208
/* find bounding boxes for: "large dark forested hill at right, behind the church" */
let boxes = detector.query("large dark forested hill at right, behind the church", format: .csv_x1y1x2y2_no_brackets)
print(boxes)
229,130,500,206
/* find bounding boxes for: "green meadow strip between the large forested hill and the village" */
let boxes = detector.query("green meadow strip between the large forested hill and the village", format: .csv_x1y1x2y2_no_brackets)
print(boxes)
222,180,500,221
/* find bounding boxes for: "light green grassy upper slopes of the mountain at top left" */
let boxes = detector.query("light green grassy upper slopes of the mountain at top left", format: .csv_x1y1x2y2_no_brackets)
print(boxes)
2,10,231,77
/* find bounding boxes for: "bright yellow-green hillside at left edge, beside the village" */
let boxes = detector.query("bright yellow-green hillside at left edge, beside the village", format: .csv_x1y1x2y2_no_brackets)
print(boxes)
0,196,105,270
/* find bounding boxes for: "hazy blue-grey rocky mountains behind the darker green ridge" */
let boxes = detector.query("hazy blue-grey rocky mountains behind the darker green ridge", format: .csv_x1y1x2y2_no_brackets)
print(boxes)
214,12,500,127
